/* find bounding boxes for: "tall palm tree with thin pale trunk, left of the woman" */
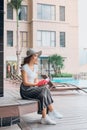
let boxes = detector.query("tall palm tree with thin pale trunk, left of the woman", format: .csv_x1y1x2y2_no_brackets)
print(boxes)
8,0,23,74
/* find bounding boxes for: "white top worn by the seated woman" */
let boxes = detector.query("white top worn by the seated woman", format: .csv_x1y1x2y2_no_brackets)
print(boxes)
22,64,38,83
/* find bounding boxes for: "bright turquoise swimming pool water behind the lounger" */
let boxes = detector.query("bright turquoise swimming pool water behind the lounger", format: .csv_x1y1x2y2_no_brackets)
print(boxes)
52,78,87,87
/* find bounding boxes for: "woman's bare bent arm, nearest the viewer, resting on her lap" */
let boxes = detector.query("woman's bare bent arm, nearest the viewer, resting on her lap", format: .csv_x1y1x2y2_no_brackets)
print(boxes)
21,70,37,86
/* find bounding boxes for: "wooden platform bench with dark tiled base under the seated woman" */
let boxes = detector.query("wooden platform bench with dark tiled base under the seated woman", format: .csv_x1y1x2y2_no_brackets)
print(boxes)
0,90,38,130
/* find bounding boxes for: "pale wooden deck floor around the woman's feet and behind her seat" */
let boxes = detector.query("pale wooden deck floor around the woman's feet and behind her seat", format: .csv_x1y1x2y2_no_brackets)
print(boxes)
0,80,87,130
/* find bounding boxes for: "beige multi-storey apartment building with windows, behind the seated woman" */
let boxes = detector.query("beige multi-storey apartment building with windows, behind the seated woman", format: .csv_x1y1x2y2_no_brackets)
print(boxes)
4,0,79,77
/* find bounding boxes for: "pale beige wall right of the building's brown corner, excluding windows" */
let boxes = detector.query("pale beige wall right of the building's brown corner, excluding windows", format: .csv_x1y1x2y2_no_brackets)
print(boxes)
33,0,79,73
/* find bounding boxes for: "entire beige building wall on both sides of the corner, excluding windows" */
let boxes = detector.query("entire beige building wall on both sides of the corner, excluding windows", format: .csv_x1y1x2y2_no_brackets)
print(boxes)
4,0,79,77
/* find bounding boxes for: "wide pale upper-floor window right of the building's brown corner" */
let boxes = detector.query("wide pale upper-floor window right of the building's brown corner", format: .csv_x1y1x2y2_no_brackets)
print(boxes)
37,4,55,20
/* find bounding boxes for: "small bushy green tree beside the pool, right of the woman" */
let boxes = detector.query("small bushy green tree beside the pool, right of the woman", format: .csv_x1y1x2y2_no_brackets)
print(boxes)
48,54,64,75
